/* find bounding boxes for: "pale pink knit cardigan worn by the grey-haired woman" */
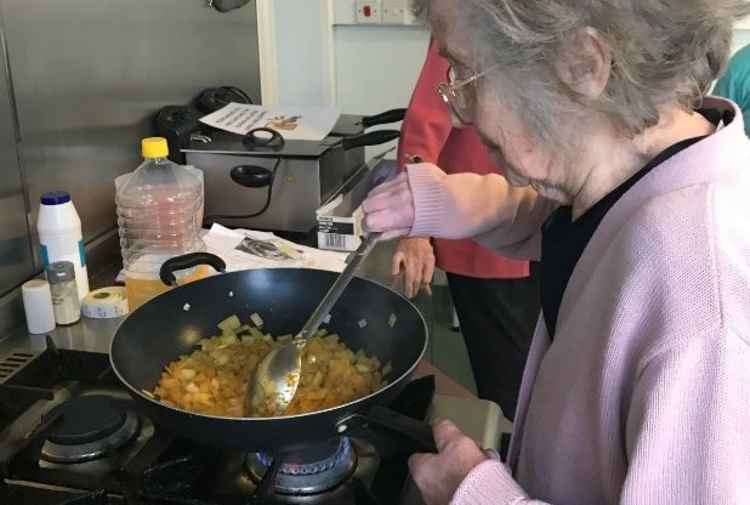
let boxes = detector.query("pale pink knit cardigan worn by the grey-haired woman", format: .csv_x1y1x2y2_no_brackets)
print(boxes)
409,99,750,505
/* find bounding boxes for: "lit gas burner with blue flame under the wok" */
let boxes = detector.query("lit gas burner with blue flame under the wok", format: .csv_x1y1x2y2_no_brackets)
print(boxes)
245,437,357,496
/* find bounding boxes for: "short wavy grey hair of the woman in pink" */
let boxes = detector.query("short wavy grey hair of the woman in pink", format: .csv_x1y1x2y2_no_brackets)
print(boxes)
455,0,750,139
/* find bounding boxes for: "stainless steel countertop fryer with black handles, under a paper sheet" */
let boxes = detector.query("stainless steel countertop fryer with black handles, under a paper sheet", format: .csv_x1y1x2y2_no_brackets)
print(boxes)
184,109,404,232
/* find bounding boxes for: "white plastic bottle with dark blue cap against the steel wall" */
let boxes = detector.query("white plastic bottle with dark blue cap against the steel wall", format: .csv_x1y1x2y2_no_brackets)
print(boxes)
36,191,89,300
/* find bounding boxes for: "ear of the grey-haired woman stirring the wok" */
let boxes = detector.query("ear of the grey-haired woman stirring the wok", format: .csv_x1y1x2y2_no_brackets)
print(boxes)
555,28,612,99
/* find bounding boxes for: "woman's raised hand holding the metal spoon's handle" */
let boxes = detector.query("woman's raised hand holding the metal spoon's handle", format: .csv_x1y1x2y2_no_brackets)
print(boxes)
362,172,414,240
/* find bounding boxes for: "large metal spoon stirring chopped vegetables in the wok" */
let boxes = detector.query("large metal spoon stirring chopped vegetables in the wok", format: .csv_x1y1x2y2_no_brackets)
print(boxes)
245,233,381,417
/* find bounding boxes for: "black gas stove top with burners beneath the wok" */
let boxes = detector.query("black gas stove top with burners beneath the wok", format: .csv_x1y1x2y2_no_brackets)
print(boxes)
0,320,501,505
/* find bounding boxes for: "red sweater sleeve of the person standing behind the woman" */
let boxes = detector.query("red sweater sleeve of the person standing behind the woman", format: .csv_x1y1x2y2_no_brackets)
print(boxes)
398,39,453,167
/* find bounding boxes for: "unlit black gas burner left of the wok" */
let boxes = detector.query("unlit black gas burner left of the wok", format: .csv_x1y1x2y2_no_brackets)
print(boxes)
41,395,140,464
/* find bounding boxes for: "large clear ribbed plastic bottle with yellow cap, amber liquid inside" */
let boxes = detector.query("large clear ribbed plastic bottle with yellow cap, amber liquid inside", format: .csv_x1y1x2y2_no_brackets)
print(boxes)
115,137,208,311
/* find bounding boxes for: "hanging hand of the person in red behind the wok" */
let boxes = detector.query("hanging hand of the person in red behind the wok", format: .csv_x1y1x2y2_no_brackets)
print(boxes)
392,237,435,298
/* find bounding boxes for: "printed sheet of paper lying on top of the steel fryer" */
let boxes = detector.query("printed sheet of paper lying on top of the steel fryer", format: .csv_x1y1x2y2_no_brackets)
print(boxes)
201,102,339,142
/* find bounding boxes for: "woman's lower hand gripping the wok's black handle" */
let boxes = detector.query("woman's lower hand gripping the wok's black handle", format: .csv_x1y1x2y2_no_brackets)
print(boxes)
409,420,487,505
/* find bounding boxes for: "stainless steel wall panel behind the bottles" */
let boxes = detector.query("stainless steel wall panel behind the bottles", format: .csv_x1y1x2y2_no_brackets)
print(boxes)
0,0,260,338
